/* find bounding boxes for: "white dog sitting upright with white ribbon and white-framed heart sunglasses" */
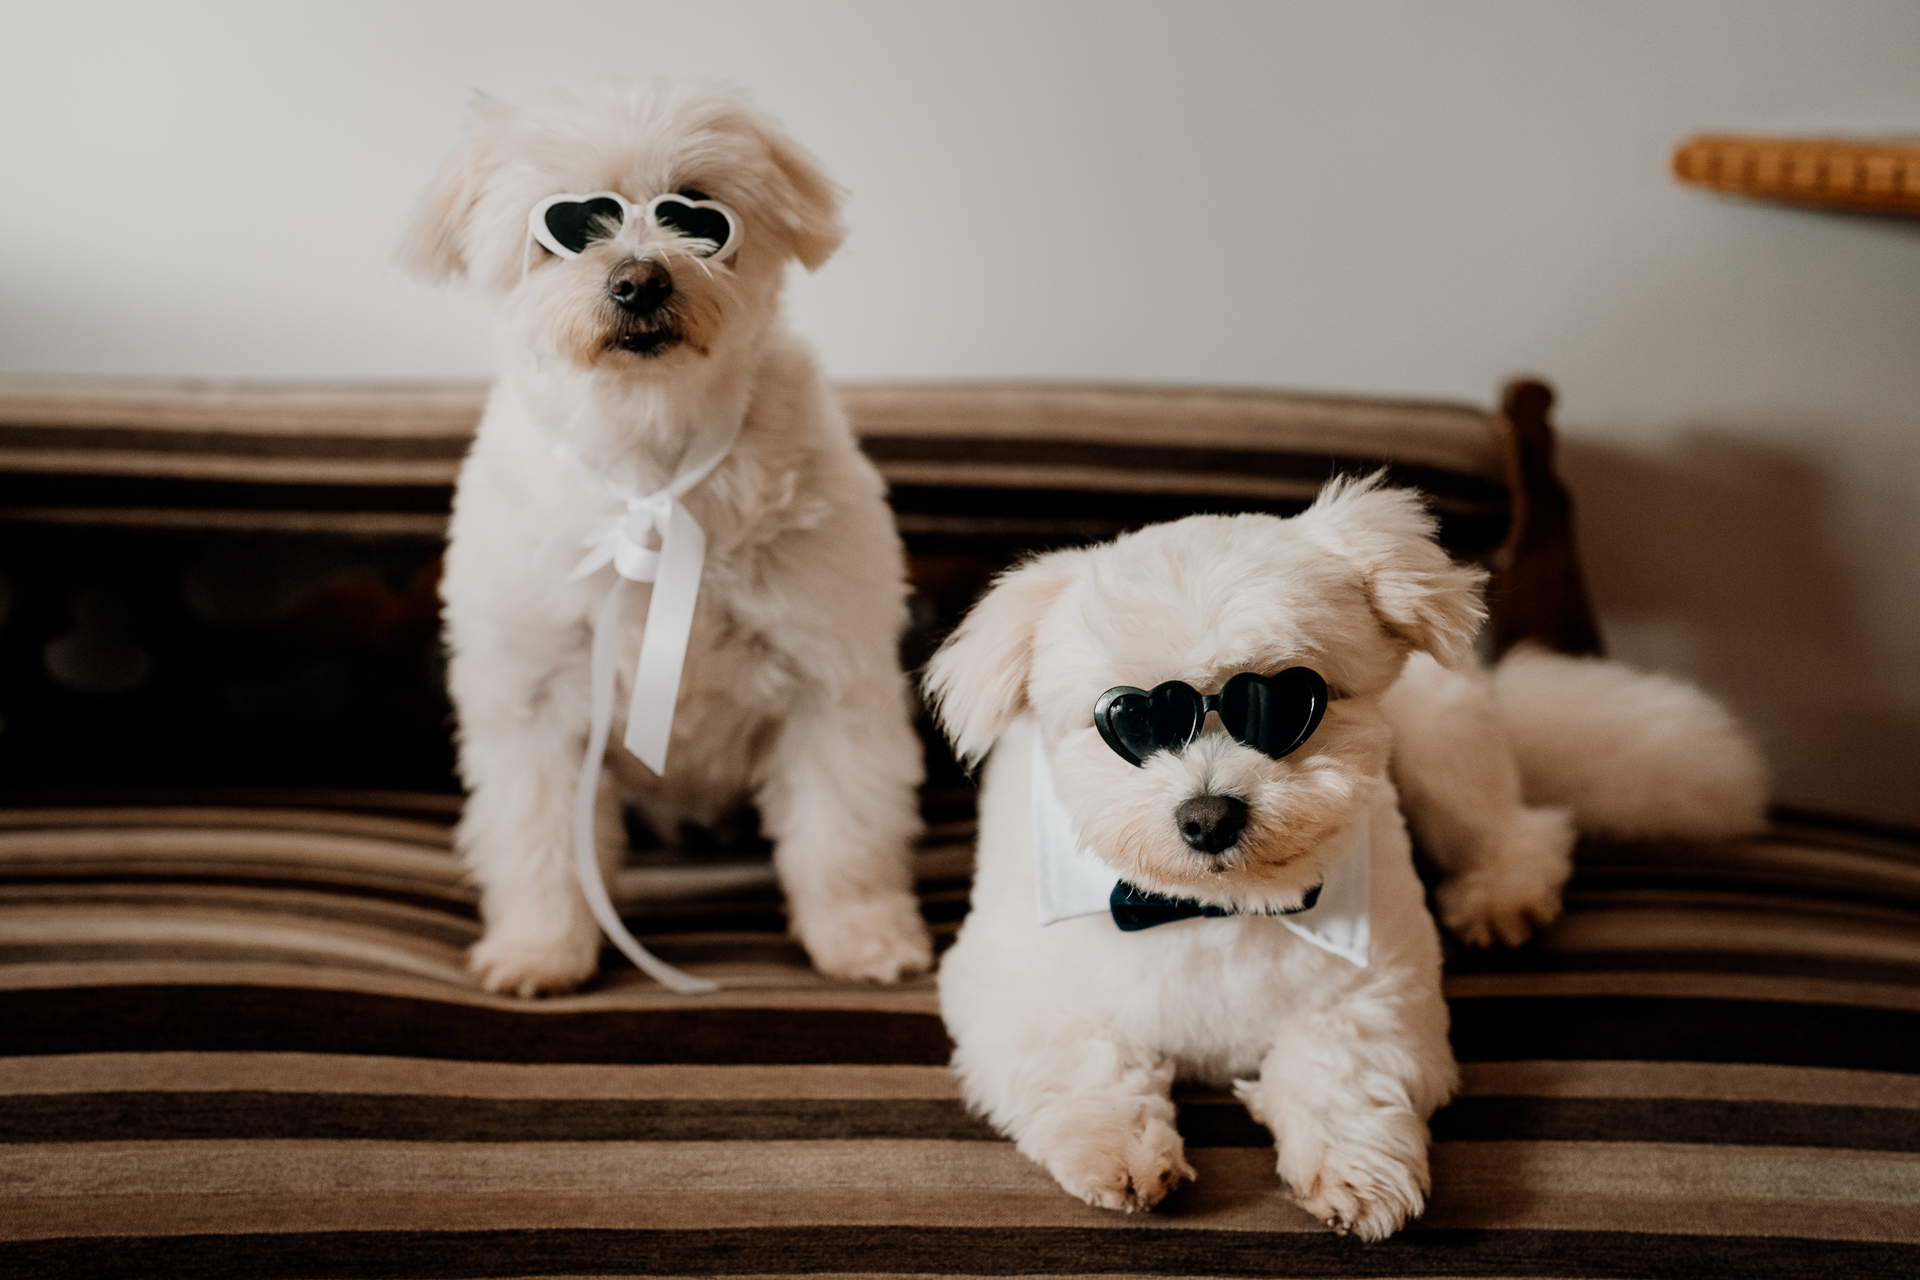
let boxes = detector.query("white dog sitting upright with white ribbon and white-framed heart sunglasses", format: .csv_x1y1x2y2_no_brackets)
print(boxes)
401,86,931,996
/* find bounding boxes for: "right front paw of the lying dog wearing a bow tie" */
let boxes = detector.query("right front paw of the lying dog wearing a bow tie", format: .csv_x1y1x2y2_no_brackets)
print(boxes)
1279,1113,1427,1240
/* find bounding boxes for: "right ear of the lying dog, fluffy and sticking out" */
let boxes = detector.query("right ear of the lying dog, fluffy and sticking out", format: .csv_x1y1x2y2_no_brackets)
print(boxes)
1300,472,1486,670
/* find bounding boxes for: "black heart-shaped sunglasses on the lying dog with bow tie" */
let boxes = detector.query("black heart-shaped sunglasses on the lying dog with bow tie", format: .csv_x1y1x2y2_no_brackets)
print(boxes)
1092,666,1327,764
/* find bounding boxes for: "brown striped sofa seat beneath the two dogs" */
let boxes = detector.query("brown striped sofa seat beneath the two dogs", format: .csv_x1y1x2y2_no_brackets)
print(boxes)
0,808,1920,1276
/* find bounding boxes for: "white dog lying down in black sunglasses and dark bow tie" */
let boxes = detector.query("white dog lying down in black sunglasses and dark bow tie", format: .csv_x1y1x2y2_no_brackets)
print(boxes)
927,482,1764,1240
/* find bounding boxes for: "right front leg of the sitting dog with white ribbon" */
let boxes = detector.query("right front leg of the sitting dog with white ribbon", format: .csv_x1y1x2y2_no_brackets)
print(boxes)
756,691,933,983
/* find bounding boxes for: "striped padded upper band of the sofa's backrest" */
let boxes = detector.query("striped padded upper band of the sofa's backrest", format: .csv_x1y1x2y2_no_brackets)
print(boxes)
0,378,1505,535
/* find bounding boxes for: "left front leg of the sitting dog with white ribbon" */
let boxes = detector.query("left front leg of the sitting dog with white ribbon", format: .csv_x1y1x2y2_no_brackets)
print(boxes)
449,651,624,996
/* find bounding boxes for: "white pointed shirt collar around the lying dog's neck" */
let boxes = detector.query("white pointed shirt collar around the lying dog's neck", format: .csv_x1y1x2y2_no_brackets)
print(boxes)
1027,720,1373,969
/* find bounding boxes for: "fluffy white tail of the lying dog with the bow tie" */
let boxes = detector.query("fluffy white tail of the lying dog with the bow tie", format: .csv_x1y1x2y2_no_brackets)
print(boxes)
1494,647,1768,841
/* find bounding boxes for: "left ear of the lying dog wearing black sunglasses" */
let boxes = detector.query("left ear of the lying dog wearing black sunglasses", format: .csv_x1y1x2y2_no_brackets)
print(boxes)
922,551,1079,768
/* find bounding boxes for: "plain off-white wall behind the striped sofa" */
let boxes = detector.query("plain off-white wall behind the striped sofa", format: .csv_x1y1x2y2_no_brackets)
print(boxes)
0,0,1920,823
